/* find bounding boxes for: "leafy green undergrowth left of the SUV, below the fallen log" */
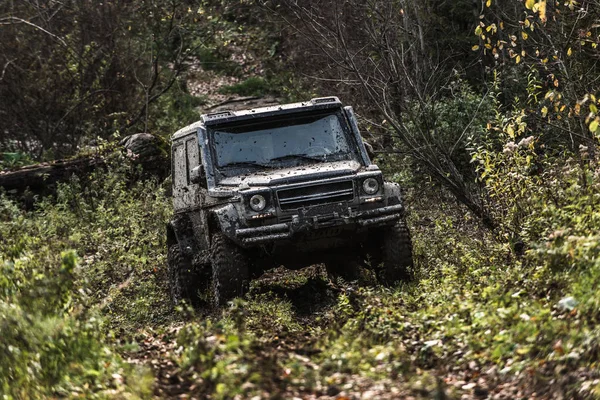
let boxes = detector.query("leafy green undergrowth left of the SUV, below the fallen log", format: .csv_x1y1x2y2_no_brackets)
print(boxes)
0,154,172,399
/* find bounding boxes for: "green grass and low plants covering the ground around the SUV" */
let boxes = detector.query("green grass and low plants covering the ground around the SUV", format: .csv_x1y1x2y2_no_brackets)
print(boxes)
0,146,600,399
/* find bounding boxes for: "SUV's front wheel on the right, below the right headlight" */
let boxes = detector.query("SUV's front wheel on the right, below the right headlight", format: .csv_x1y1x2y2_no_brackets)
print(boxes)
378,218,415,286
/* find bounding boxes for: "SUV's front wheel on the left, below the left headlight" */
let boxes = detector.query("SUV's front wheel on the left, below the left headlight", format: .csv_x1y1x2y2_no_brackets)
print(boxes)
211,233,249,307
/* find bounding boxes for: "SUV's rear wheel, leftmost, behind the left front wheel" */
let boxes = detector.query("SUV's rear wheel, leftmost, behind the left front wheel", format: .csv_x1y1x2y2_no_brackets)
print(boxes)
167,244,200,304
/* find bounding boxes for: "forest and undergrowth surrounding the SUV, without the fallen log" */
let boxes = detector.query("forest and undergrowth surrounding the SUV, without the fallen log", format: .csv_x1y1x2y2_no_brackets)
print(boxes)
0,0,600,399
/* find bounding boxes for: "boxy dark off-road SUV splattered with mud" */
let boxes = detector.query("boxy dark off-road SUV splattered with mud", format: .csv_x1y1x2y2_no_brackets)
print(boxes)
167,97,412,305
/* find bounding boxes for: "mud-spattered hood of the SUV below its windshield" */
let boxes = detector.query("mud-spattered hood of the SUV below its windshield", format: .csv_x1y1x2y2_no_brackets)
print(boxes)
219,160,361,187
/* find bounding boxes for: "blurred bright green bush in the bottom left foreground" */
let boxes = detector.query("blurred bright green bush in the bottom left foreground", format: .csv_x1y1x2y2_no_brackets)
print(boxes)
0,251,149,399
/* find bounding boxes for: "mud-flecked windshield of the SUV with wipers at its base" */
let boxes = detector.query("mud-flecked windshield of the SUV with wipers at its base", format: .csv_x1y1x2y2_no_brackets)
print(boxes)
211,111,358,176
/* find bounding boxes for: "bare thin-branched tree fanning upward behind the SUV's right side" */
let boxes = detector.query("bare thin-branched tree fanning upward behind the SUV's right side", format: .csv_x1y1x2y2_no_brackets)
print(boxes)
272,0,494,227
